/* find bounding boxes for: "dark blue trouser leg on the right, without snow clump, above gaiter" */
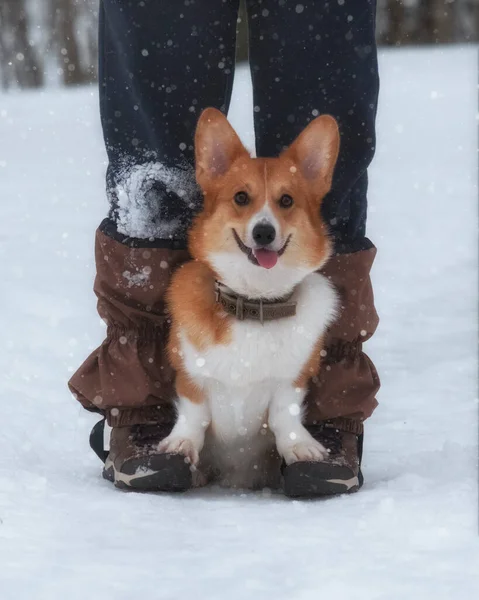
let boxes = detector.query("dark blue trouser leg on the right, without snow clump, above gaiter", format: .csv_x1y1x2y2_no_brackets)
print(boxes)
248,0,379,248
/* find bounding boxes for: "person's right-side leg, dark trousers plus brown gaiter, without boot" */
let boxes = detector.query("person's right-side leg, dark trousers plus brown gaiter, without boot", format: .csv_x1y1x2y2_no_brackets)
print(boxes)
248,0,379,491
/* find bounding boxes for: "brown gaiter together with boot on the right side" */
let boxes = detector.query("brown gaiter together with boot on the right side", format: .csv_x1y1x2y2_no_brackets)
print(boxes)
283,248,379,497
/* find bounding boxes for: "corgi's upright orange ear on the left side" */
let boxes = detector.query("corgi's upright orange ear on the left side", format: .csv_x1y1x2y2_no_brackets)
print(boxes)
195,108,249,188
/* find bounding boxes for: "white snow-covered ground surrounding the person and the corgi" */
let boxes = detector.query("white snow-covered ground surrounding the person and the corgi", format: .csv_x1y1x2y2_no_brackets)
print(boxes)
0,48,479,600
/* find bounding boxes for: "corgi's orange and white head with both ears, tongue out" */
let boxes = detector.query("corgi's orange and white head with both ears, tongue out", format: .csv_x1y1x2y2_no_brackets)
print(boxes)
190,108,339,298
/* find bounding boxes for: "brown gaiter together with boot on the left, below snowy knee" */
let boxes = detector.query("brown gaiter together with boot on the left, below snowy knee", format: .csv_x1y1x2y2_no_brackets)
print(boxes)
69,219,191,490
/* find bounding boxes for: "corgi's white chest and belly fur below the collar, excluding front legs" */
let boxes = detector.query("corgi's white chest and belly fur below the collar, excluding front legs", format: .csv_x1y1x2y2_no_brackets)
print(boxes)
176,273,336,487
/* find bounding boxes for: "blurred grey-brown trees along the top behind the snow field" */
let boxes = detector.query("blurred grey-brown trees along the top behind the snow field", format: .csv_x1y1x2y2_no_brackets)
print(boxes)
0,0,479,89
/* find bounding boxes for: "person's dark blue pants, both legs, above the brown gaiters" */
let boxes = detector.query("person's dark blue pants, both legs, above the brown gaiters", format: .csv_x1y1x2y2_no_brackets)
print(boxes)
100,0,379,253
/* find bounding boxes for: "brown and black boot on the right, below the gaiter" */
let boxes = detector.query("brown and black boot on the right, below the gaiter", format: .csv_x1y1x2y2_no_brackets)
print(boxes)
283,419,363,498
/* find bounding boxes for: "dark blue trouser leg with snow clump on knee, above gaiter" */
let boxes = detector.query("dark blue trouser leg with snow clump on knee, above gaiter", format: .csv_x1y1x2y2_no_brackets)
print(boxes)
100,0,239,242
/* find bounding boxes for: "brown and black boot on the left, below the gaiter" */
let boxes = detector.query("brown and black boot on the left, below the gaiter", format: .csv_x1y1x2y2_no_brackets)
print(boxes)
103,425,192,492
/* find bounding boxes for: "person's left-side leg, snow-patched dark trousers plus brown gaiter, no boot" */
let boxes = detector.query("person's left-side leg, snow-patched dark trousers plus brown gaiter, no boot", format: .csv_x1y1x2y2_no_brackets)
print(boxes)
69,0,238,485
